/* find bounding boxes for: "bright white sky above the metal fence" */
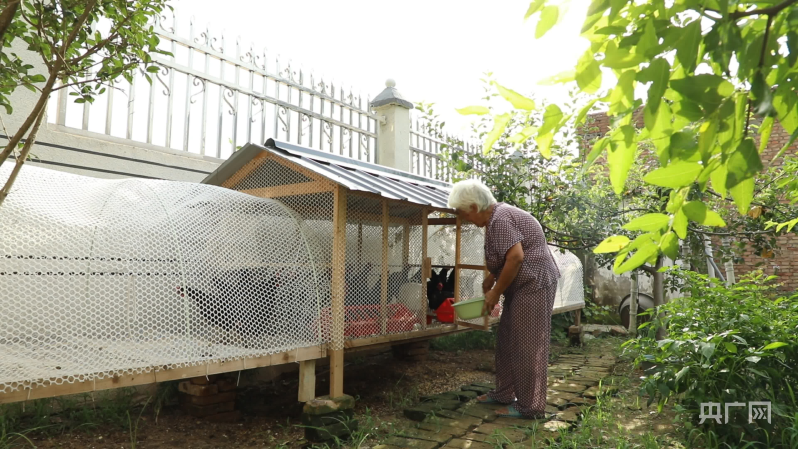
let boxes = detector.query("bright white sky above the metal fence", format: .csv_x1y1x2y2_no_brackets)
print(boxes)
172,0,610,133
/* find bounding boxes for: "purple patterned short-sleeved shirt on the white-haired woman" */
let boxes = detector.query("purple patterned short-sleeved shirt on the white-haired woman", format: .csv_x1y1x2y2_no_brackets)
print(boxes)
485,203,560,296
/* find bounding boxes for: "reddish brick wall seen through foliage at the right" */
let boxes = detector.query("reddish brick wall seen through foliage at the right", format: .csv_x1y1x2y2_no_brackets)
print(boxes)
588,109,798,291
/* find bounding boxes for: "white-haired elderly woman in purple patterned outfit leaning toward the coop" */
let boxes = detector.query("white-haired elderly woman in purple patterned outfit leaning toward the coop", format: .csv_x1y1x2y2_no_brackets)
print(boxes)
449,180,560,418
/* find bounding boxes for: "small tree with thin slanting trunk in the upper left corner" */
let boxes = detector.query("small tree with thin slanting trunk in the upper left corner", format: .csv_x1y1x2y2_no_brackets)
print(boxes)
0,0,169,205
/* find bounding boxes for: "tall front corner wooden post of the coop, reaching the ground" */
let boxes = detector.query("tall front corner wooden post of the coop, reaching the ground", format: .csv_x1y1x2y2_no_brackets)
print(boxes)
330,186,346,398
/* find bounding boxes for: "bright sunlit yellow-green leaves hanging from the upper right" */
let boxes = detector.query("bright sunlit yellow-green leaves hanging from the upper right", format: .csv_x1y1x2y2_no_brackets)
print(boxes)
461,0,798,272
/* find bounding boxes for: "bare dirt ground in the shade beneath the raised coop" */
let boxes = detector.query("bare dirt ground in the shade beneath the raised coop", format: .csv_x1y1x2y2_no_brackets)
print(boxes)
26,349,512,449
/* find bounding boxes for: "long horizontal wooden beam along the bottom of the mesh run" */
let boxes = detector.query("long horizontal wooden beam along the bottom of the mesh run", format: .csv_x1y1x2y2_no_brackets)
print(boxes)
0,346,326,404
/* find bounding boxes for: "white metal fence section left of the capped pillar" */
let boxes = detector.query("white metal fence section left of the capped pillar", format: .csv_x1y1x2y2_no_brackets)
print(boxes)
48,10,377,162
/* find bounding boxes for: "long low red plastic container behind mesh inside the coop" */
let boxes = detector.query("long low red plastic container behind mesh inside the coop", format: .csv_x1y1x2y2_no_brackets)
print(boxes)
314,304,421,339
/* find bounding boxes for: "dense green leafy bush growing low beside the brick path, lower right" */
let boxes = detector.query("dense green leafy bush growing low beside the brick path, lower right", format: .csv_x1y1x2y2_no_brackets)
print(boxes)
625,271,798,447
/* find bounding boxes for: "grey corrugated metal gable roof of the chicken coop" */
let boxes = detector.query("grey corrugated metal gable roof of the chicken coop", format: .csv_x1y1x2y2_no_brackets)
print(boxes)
202,139,452,209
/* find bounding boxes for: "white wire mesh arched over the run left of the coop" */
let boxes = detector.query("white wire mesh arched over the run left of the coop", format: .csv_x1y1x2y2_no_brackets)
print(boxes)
0,166,328,392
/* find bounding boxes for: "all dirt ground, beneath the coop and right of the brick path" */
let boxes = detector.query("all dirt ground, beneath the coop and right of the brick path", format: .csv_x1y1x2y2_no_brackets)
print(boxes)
10,338,683,449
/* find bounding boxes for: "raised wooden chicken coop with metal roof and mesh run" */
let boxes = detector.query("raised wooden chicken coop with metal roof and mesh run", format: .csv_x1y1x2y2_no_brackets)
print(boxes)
0,140,584,403
